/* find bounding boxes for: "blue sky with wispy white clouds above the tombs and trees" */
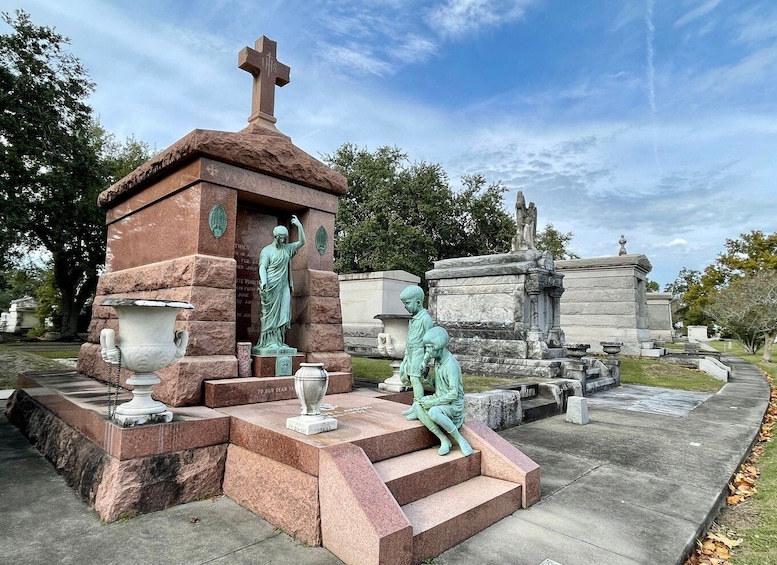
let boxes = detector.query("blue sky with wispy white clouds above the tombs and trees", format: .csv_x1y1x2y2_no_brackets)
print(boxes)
7,0,777,288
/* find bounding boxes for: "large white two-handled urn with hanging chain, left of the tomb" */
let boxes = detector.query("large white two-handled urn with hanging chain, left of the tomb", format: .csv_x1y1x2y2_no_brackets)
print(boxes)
100,298,194,427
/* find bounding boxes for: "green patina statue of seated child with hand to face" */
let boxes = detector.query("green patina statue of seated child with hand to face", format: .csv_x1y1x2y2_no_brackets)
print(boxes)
412,326,472,455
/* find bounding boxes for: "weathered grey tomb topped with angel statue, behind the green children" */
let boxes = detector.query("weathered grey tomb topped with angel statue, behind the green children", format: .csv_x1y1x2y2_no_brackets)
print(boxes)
426,191,564,377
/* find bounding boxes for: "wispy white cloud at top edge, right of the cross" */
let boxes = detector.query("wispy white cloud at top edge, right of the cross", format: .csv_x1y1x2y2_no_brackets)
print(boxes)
427,0,533,38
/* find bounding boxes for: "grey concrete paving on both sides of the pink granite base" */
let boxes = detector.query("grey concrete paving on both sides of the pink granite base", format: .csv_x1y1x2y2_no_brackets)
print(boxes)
0,358,769,565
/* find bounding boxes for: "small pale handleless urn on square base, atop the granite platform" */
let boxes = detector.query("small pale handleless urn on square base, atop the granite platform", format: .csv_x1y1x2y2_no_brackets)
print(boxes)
286,363,337,435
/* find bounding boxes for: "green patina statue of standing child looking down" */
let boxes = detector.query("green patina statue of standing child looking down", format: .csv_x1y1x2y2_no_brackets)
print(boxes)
399,285,434,414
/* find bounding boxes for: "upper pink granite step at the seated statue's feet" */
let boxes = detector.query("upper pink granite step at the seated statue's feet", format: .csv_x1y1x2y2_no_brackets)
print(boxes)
375,446,480,506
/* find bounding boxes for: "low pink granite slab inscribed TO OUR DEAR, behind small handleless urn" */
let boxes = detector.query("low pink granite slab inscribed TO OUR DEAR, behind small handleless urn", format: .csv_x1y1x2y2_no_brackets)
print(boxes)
203,371,353,408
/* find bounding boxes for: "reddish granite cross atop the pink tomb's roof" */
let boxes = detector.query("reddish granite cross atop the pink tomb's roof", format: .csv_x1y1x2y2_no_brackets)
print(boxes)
237,35,290,129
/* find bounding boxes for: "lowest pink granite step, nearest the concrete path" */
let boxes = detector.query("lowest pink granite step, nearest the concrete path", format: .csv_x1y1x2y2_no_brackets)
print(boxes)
402,476,521,563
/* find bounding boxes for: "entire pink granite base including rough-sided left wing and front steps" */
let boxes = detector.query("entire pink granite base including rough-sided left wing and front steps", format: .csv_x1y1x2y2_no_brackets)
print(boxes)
6,372,540,565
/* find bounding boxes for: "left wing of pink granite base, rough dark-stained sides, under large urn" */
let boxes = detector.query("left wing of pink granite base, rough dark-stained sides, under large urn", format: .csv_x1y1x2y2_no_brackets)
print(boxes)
6,371,230,522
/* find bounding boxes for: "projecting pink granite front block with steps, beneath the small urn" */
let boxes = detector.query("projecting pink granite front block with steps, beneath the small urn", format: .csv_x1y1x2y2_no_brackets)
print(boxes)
220,391,539,564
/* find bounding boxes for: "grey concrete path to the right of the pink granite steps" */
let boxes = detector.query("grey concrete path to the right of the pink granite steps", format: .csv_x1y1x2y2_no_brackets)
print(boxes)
435,358,769,565
